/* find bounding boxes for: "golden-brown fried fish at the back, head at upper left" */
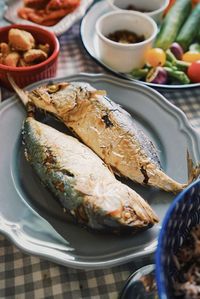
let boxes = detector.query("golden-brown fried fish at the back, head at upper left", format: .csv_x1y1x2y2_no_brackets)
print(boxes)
28,82,186,193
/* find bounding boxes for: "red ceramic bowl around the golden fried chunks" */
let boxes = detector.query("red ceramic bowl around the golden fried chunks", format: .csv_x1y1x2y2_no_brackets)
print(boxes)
0,24,60,88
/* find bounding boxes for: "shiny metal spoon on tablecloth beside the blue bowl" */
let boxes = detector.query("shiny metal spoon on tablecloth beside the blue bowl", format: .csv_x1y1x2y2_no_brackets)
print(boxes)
119,265,158,299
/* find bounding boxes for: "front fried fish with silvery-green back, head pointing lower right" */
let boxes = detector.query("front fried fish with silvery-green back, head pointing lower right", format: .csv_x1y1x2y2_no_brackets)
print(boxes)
23,117,158,233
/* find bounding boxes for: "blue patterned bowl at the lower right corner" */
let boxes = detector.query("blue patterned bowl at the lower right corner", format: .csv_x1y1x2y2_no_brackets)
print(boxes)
156,180,200,299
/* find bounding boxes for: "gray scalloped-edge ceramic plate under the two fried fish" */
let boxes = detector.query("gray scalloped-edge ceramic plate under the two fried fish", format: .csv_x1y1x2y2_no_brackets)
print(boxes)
0,74,200,269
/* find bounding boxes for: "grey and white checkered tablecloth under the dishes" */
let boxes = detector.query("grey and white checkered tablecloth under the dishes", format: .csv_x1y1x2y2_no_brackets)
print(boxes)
0,1,200,299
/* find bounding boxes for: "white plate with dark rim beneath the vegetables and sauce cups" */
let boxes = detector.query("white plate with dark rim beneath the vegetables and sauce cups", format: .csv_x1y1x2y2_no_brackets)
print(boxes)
81,0,200,89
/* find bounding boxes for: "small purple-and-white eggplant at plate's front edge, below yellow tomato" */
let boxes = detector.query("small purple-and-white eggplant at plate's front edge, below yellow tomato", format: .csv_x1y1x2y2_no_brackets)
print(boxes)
146,66,168,84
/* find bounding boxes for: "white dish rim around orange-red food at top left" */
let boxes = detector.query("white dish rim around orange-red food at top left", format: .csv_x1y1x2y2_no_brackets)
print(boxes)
4,0,93,36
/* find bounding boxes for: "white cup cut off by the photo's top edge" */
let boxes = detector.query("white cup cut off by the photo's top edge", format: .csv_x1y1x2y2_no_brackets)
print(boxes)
107,0,169,24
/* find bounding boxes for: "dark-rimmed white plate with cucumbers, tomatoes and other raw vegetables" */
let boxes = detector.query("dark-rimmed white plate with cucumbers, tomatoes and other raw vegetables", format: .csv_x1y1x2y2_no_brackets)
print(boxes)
81,0,200,89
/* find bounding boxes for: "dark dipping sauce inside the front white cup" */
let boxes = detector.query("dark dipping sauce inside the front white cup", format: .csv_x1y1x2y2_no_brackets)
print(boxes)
107,30,145,44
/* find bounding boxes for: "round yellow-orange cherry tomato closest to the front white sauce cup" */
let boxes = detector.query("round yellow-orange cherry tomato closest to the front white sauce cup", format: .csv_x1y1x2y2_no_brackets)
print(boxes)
145,48,166,67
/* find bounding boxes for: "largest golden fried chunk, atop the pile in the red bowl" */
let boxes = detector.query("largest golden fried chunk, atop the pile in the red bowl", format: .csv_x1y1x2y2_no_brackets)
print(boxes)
8,28,35,51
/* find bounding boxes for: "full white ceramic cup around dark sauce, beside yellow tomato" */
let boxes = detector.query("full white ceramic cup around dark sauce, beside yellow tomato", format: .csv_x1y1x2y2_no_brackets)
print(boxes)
95,10,158,73
